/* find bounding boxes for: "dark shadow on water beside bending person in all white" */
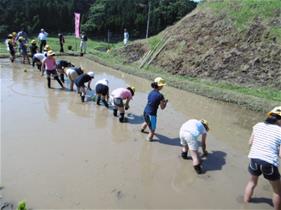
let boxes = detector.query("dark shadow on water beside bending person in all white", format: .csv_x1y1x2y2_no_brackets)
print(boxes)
203,151,226,171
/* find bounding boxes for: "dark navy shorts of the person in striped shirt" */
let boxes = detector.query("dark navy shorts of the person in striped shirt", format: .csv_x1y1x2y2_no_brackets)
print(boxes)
248,158,280,181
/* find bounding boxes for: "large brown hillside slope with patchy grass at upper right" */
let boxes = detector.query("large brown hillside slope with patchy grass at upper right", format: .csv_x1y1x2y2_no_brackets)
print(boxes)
118,0,281,90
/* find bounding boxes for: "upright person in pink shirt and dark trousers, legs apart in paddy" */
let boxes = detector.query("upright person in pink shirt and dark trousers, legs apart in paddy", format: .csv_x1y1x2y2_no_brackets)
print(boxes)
41,50,64,89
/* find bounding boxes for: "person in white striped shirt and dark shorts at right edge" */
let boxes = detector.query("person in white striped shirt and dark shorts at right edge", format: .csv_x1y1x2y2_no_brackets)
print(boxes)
244,106,281,210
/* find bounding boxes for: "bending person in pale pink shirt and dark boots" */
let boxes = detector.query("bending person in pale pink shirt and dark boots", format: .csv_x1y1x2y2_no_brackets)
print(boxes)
111,87,135,122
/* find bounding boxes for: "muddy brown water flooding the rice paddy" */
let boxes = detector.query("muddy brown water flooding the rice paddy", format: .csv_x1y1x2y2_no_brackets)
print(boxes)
0,57,272,209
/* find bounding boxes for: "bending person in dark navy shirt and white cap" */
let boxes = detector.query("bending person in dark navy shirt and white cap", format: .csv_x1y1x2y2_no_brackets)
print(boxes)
74,71,94,102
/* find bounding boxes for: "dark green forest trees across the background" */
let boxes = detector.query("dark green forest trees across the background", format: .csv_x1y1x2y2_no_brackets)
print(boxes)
0,0,196,38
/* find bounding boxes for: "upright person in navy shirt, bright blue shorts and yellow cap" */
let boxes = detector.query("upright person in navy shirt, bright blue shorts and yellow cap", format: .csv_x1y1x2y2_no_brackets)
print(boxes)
141,77,168,141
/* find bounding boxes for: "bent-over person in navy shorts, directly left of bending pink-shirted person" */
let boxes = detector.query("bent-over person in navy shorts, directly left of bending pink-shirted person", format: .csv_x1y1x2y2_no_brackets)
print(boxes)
95,79,109,108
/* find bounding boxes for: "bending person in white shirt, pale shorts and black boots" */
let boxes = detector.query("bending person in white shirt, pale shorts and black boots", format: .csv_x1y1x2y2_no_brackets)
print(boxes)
179,119,209,174
